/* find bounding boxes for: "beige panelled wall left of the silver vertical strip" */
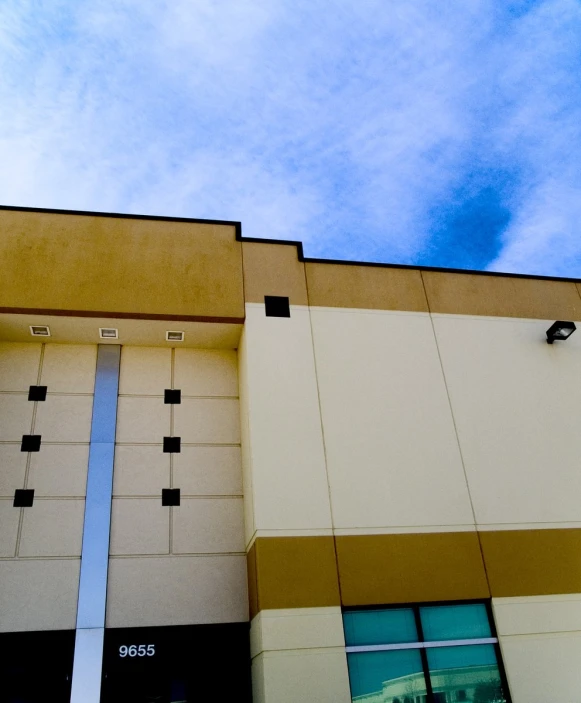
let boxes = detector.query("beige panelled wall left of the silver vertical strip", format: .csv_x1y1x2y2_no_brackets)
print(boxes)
0,343,97,631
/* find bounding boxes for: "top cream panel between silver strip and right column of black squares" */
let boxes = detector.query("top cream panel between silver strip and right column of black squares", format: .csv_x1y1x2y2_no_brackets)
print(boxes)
119,346,171,395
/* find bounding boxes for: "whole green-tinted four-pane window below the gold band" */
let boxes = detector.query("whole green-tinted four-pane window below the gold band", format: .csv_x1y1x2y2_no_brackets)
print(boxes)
343,603,509,703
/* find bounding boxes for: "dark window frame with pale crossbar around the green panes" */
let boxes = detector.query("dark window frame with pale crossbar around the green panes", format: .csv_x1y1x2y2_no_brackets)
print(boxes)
341,598,512,703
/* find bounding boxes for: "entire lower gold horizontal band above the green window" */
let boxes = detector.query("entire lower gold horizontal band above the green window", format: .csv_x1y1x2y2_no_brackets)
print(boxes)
248,528,581,617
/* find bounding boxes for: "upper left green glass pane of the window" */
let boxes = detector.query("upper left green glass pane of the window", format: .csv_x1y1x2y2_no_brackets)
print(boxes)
343,608,418,647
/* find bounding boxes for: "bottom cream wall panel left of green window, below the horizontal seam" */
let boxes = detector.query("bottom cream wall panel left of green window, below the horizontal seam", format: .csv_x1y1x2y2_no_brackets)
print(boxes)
252,648,351,703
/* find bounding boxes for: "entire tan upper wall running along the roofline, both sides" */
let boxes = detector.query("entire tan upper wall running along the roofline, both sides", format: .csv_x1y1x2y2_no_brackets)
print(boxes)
0,209,581,322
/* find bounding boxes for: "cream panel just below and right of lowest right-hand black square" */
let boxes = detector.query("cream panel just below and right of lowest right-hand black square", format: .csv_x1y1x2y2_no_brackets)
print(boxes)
173,498,244,554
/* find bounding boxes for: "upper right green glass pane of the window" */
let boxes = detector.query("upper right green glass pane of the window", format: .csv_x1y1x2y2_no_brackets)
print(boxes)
420,603,492,642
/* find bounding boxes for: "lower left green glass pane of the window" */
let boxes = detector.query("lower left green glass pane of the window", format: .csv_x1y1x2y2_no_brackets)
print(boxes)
347,649,426,703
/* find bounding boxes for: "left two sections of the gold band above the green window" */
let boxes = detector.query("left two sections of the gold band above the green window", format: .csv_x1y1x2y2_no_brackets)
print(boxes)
248,532,490,617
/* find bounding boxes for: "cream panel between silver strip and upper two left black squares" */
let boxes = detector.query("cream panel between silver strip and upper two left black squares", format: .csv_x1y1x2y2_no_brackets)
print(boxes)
34,395,93,440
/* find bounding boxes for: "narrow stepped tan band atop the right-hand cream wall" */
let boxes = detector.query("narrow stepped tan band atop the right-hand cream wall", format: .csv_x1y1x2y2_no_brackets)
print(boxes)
242,242,581,320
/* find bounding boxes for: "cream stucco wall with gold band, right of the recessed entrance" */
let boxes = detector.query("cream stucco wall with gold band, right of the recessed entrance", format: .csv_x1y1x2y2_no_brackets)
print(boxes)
240,300,581,703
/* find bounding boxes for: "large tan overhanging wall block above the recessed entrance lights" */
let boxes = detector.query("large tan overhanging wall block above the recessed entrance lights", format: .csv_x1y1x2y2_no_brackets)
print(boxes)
0,210,244,321
